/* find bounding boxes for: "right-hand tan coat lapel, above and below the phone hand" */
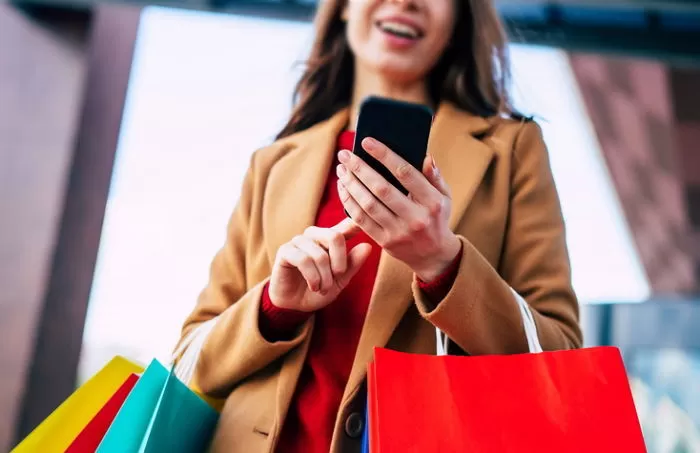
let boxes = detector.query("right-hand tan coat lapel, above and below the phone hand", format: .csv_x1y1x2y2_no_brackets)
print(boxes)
343,103,494,401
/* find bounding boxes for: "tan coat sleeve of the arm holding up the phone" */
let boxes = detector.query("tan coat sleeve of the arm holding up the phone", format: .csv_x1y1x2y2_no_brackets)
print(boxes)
413,122,582,355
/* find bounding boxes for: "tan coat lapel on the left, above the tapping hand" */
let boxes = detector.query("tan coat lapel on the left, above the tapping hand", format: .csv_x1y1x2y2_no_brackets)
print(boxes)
263,110,348,263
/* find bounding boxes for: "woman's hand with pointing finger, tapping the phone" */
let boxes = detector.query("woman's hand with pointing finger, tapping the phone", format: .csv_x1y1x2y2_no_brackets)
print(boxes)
268,219,371,312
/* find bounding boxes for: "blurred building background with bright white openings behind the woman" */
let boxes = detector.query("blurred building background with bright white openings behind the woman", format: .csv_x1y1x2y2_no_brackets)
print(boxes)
0,0,700,453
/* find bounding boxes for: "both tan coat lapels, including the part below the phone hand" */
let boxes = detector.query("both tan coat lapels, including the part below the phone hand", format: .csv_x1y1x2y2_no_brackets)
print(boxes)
263,103,495,399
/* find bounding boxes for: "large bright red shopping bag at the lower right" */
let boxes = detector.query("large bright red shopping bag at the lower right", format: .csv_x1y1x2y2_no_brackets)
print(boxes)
368,347,646,453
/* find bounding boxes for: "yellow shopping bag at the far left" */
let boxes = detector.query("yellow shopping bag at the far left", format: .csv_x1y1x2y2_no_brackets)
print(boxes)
11,356,143,453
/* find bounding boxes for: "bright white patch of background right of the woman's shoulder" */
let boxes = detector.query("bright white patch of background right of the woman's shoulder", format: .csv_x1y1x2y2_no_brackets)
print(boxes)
511,46,649,302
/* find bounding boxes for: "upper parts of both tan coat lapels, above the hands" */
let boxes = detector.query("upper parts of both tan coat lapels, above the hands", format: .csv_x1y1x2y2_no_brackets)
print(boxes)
263,103,493,260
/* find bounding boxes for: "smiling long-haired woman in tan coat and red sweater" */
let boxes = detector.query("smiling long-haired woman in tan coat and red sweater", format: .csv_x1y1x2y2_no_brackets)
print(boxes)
175,0,581,453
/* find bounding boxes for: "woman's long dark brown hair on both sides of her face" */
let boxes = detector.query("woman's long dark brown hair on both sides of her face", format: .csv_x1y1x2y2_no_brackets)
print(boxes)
277,0,516,139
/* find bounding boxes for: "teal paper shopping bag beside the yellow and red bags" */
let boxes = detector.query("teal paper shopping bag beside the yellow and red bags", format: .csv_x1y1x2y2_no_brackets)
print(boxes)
97,360,219,453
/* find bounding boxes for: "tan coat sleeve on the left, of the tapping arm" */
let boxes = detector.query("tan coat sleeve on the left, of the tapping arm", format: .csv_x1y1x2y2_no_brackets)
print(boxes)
175,152,310,397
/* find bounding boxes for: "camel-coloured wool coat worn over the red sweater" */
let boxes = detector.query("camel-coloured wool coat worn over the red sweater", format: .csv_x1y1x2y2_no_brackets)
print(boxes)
178,104,581,453
